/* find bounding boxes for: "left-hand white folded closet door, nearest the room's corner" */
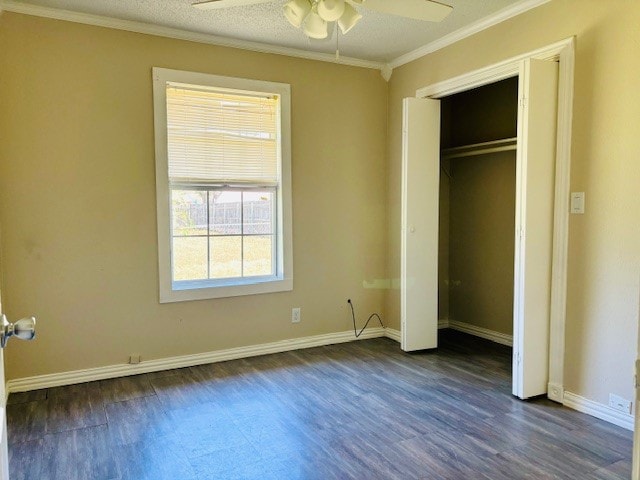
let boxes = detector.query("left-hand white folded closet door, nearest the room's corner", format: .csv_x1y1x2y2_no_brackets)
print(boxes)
400,98,440,352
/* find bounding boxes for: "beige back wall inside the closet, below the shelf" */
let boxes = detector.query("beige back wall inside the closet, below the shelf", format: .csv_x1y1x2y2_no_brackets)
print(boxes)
449,152,516,335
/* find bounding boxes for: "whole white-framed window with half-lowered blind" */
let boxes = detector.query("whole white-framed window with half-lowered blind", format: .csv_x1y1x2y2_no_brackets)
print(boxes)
153,68,293,303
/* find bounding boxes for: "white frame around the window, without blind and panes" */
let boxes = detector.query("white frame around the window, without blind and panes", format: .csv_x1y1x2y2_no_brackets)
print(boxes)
152,67,293,303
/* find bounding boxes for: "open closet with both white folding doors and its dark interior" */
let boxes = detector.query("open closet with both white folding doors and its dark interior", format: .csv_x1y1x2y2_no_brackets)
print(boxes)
400,58,558,399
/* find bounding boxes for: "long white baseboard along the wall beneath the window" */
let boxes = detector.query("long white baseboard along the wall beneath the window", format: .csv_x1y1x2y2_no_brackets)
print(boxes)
7,327,384,393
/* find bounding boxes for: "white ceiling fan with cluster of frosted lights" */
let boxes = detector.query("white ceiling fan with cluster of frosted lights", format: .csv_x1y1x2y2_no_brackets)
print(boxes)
193,0,453,39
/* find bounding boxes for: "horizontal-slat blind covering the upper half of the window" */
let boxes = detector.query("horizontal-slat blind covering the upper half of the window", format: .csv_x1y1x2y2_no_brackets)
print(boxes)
166,84,279,185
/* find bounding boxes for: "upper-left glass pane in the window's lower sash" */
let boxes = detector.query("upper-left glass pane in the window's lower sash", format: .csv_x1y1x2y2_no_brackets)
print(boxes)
171,190,207,237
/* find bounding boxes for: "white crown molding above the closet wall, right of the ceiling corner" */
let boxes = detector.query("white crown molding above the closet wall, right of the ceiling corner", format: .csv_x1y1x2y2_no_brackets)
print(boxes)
388,0,551,69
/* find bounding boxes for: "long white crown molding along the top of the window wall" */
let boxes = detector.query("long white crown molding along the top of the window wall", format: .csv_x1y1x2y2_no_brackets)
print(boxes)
0,0,386,70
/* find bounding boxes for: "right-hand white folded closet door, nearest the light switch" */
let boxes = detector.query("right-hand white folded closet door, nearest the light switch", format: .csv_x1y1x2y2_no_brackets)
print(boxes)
513,60,558,398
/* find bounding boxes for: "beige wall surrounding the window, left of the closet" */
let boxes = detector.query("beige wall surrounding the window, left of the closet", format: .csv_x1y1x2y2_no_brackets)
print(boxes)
0,13,387,378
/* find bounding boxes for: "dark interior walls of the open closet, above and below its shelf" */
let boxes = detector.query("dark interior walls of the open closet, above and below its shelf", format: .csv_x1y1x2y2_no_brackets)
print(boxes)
438,77,518,335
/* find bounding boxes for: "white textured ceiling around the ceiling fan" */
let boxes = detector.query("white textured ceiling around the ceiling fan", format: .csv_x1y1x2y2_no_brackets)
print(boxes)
12,0,521,62
